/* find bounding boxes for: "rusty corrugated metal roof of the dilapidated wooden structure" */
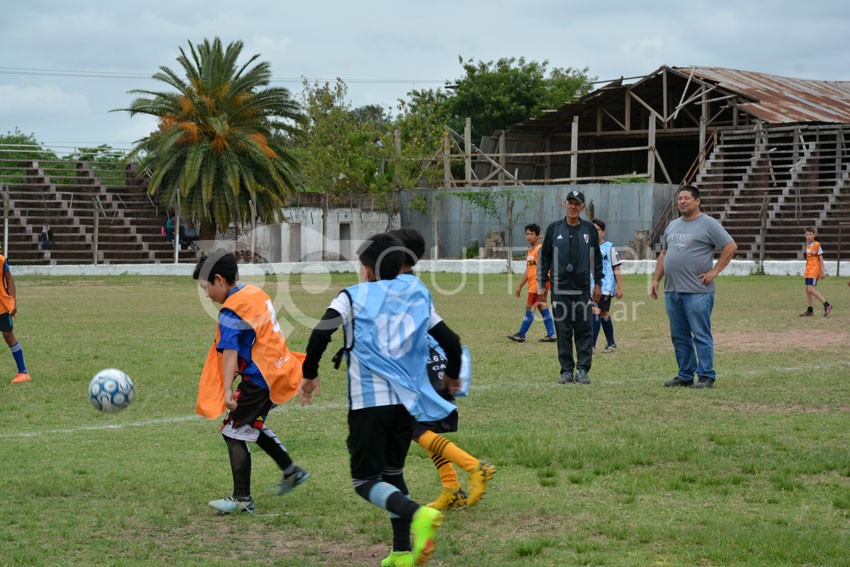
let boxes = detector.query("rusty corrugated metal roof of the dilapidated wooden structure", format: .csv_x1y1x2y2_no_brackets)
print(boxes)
672,67,850,124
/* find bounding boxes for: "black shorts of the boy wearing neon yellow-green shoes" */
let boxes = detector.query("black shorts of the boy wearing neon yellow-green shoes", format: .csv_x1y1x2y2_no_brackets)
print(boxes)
348,405,414,480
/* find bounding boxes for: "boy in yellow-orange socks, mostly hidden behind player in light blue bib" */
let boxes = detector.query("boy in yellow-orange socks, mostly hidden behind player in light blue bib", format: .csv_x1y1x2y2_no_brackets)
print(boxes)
390,228,496,510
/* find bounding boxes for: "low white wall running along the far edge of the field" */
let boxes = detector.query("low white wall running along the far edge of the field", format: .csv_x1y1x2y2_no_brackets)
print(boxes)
12,260,850,277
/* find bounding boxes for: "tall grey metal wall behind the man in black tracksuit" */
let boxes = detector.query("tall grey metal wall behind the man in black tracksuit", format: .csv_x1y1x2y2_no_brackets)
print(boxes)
401,183,676,258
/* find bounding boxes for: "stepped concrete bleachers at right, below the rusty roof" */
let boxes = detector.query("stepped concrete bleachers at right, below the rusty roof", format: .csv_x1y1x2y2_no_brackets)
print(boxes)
696,126,850,260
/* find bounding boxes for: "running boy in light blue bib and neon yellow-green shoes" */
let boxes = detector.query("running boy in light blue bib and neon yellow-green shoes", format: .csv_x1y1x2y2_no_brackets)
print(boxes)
300,234,461,567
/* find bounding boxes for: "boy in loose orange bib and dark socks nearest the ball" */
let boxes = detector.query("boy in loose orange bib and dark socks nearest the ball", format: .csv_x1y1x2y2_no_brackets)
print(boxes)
193,252,309,514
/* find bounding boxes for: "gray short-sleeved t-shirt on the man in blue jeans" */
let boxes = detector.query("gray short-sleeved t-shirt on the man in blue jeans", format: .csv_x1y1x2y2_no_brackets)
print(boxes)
661,214,732,293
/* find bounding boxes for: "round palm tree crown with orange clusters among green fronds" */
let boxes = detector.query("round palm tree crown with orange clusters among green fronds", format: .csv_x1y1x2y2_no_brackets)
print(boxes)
118,38,303,239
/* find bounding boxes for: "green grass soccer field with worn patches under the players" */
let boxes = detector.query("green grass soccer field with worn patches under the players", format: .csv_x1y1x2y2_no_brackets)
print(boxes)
0,274,850,566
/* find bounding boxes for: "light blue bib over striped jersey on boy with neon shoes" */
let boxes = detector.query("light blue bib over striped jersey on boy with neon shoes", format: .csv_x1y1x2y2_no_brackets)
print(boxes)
330,274,441,417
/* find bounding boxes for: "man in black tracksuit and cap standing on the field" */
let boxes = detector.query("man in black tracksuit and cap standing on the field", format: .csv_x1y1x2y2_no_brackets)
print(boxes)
537,191,602,384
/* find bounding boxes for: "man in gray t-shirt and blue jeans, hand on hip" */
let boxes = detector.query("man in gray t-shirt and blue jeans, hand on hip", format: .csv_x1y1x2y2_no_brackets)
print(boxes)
650,185,738,388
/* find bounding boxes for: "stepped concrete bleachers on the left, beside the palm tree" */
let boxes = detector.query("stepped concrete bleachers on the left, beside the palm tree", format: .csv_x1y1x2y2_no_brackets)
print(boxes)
0,158,197,265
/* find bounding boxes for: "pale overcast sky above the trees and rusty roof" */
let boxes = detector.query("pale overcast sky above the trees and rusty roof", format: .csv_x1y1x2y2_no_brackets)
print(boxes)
0,0,850,153
